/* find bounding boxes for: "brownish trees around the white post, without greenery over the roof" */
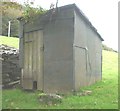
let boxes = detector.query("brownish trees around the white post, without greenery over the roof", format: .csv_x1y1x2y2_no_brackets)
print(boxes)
1,2,22,37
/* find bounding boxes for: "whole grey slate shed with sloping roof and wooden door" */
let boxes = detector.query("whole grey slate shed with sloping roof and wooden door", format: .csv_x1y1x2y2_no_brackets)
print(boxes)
19,4,103,93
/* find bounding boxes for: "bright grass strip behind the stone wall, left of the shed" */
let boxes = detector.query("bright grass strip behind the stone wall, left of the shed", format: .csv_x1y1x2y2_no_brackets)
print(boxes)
0,36,19,48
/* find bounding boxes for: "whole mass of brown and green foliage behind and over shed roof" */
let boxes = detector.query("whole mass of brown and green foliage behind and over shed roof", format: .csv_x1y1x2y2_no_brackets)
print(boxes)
0,2,45,37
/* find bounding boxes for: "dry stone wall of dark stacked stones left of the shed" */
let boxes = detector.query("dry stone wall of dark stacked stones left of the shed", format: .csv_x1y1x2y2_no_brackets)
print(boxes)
0,45,20,88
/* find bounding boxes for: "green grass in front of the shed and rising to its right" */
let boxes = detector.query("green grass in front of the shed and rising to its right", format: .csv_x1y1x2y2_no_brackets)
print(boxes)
2,36,118,109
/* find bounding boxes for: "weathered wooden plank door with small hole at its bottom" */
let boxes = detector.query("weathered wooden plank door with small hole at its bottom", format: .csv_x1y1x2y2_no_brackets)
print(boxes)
22,30,43,90
